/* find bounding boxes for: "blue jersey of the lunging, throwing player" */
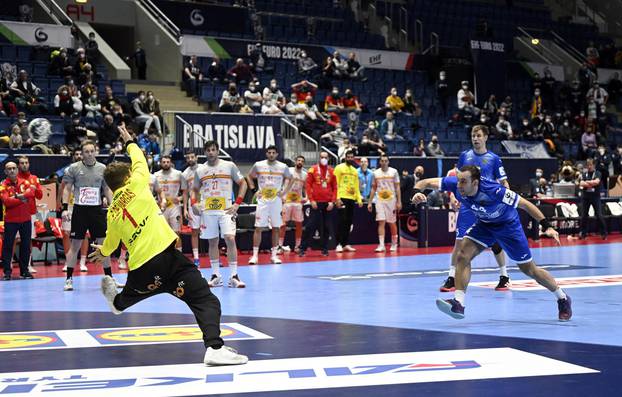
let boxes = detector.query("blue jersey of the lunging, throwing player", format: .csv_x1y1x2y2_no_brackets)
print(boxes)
441,176,520,223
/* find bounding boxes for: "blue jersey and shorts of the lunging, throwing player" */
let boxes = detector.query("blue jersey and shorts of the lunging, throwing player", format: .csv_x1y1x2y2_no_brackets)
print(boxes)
441,176,531,264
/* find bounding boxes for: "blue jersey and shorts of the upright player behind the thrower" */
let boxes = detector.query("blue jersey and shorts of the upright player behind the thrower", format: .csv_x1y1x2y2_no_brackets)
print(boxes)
456,149,507,240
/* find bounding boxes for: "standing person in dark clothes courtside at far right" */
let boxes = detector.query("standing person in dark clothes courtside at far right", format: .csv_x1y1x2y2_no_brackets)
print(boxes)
579,159,607,240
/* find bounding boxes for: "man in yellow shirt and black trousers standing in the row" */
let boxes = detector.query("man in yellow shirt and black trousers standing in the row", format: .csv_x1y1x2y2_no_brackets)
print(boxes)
335,150,363,252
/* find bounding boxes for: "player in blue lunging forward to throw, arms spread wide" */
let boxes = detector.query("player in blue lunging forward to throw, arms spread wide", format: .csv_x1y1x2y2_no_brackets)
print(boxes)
412,165,572,321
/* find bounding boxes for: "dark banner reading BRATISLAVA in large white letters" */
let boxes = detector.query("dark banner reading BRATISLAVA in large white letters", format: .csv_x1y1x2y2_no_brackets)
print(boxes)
175,112,283,162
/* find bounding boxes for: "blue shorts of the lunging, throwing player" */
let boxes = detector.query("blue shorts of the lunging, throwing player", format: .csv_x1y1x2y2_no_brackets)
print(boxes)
464,218,531,264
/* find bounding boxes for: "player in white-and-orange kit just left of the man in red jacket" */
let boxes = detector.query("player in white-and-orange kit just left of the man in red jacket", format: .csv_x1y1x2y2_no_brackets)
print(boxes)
279,156,307,252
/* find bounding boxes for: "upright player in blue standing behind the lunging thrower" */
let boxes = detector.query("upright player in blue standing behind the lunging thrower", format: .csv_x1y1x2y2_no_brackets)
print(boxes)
441,125,510,292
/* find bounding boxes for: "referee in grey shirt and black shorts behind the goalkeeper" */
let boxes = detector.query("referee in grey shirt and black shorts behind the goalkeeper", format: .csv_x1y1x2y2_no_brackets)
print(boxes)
62,140,112,291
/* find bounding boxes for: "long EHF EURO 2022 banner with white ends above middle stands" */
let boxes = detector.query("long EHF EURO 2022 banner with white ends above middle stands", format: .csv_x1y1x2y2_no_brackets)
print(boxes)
181,35,414,70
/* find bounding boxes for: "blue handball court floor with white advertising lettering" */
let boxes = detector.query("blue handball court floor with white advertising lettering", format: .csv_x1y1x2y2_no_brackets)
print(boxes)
0,243,622,397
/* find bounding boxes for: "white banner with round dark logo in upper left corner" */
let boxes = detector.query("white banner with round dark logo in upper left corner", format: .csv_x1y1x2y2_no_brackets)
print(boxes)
0,21,72,48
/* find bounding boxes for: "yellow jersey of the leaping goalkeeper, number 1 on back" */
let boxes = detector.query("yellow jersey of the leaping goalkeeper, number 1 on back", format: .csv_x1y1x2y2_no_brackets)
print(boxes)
101,143,177,270
